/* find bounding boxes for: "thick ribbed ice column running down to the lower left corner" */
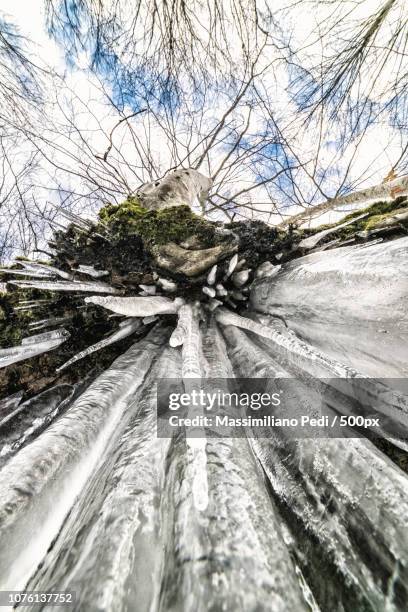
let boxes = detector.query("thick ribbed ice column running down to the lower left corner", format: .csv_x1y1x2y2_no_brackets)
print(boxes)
0,330,167,589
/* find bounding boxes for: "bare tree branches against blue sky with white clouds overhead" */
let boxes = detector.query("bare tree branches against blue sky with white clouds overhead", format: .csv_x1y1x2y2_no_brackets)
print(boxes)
0,0,408,259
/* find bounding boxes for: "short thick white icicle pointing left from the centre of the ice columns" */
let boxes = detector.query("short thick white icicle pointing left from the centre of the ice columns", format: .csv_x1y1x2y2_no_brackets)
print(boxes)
85,295,183,317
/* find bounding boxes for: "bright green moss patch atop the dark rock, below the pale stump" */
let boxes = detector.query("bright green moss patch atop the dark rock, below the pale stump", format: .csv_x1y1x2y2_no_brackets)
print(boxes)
99,198,216,248
